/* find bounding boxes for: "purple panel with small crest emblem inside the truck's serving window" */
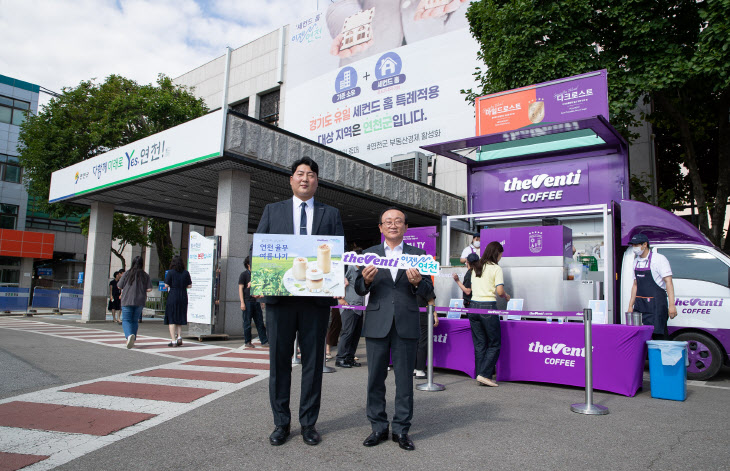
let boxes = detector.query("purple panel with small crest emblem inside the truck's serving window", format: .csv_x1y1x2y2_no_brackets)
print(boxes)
480,226,573,257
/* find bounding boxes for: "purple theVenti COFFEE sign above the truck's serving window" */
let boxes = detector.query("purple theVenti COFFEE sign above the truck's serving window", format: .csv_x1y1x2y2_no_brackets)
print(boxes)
469,155,628,213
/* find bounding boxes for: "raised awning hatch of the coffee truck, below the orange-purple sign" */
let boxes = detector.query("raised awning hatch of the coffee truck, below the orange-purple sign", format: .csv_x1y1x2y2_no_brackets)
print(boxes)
422,116,627,166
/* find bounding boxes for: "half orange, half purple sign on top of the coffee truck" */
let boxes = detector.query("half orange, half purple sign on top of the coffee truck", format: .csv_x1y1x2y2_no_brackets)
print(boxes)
476,69,608,136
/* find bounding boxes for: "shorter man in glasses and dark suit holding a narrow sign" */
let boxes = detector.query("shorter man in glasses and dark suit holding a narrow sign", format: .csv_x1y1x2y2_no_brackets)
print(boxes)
355,208,433,450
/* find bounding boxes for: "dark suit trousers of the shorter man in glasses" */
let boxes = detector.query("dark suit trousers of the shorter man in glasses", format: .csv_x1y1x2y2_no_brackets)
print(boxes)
365,321,418,434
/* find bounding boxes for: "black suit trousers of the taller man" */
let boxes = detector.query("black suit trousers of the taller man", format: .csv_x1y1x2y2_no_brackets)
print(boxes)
266,298,330,426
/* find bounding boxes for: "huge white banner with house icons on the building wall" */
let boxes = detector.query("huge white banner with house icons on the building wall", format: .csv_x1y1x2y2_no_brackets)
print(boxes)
282,0,478,164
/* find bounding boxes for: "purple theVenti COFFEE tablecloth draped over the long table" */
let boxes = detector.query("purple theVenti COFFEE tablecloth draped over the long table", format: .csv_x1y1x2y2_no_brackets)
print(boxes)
433,319,652,396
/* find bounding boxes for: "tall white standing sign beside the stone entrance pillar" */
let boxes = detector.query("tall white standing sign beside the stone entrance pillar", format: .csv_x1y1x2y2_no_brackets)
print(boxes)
188,232,215,324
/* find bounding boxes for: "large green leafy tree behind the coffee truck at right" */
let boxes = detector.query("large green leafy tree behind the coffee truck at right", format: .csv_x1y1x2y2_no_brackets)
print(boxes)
467,0,730,249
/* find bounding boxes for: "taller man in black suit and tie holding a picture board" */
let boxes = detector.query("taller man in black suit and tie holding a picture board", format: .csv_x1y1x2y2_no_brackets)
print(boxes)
256,157,345,446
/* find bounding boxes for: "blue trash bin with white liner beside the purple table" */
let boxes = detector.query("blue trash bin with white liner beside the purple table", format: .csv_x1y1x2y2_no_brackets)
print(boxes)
646,340,688,401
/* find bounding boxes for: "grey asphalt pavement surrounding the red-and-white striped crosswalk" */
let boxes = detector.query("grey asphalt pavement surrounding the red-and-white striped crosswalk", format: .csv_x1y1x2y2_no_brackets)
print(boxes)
0,316,730,470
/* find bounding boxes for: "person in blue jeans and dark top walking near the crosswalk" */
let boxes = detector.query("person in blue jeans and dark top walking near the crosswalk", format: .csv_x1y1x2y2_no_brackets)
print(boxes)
117,255,152,348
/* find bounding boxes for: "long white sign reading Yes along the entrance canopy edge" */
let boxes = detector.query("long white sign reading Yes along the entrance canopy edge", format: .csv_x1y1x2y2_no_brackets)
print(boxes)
48,110,223,202
